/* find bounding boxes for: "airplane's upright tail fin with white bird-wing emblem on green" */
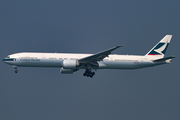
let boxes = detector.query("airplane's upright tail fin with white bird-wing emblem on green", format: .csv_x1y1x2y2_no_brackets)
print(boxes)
145,35,172,58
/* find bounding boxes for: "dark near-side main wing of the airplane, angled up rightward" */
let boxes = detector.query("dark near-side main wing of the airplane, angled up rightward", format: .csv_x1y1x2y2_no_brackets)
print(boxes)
78,45,122,64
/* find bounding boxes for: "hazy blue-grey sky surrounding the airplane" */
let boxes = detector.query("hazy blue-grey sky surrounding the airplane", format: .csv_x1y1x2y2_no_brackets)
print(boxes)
0,0,180,120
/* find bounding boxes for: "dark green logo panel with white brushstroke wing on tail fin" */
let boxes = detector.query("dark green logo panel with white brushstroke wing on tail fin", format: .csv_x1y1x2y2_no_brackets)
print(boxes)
148,43,169,55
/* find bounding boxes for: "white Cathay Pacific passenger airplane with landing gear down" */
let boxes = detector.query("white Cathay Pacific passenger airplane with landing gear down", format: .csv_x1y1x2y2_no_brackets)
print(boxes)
3,35,175,78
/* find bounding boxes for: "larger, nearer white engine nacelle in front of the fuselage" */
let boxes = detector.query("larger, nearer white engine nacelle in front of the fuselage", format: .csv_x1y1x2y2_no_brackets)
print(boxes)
63,60,79,69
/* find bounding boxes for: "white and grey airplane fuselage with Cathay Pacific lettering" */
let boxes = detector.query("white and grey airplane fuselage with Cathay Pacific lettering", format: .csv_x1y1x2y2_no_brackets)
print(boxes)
3,52,169,69
